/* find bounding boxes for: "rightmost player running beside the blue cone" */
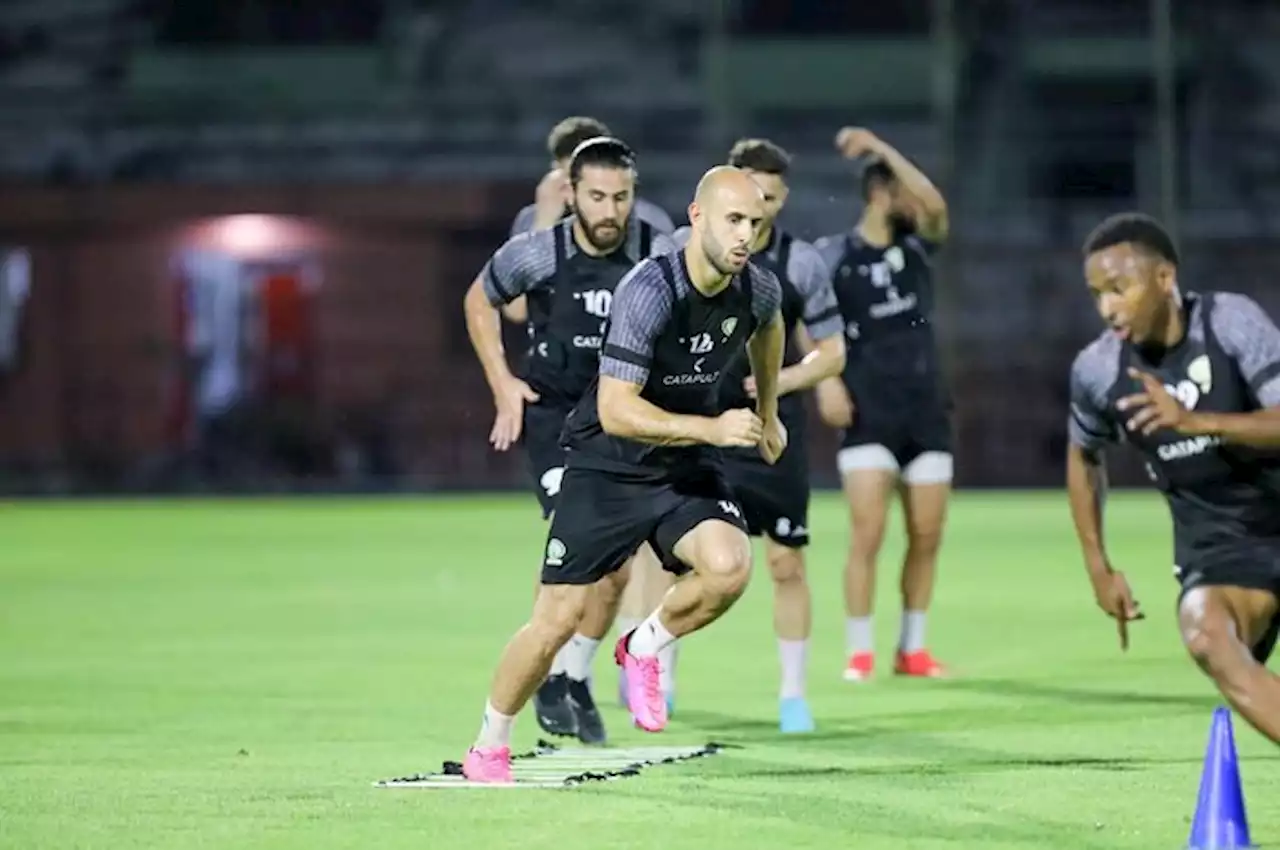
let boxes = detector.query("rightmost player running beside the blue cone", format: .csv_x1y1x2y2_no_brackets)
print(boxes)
1066,213,1280,744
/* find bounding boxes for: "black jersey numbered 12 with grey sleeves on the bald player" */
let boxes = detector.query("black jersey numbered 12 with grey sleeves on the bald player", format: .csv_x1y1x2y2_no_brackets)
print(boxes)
564,251,782,475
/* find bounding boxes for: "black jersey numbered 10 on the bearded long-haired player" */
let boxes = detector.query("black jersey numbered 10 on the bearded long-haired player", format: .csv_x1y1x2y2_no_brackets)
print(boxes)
480,216,675,406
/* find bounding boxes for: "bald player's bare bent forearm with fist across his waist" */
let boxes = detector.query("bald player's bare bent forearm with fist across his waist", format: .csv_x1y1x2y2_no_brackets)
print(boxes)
599,375,763,447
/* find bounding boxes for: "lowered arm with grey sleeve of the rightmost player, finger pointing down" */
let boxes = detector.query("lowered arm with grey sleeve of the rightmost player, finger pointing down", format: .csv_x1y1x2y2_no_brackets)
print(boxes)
1066,349,1143,649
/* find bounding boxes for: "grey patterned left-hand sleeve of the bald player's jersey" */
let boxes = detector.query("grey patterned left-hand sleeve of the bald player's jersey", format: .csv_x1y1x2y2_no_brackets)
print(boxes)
600,260,673,387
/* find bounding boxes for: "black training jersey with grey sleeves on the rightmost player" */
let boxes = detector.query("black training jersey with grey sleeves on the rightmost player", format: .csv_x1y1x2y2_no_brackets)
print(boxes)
1068,292,1280,568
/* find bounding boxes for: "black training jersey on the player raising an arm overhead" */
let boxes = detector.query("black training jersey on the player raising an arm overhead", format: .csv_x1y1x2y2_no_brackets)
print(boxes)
814,224,942,403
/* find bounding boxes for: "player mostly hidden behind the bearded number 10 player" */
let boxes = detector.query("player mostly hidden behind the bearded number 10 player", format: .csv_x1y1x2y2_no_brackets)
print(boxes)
502,115,677,707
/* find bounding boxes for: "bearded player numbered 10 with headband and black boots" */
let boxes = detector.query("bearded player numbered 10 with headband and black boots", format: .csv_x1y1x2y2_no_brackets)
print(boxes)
466,137,675,744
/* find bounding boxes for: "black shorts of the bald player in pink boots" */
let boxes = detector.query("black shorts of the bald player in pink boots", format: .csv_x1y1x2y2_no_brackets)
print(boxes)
543,465,746,585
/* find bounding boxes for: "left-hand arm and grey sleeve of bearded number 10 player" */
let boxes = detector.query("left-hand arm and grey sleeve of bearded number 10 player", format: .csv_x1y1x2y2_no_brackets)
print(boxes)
463,230,556,452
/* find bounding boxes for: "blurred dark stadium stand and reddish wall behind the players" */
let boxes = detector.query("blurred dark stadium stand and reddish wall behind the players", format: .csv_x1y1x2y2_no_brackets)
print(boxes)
0,0,1280,494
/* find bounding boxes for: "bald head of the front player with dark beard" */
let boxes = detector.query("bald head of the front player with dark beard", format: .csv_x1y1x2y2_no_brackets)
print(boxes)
689,165,764,275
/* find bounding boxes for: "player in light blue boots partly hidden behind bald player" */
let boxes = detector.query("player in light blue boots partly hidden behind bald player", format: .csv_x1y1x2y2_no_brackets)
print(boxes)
675,138,845,734
